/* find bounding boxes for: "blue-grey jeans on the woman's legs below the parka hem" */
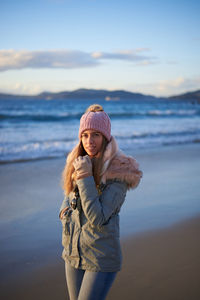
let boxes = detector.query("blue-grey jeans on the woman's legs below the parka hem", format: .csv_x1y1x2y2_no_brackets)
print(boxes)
65,263,117,300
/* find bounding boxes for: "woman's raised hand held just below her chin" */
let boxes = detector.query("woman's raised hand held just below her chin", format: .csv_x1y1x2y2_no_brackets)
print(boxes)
73,155,92,179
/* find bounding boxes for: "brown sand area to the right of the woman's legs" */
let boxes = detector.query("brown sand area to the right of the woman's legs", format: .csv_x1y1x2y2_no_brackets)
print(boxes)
108,218,200,300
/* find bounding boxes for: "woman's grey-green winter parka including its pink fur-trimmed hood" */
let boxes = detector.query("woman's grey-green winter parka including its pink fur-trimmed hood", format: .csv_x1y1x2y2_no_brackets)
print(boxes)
60,138,142,272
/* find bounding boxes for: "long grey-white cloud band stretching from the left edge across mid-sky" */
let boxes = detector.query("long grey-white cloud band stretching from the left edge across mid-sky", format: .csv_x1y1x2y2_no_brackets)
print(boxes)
0,48,155,72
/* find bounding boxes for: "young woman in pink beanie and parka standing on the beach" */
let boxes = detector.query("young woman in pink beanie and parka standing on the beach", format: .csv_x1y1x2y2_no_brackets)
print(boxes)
60,105,142,300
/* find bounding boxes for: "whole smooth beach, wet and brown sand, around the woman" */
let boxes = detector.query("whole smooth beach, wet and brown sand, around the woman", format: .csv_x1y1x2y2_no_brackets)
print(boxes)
0,144,200,300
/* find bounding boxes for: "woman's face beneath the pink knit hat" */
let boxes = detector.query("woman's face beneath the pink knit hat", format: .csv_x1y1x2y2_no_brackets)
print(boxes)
81,129,103,157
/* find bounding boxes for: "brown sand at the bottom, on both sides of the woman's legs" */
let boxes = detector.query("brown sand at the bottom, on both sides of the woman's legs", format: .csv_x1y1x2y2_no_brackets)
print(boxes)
1,215,200,300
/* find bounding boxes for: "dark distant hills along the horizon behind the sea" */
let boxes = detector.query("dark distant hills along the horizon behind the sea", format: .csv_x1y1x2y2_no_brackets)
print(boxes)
0,89,200,103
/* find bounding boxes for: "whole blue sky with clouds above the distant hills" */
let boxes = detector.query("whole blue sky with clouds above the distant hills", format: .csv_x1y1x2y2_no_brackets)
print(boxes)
0,0,200,96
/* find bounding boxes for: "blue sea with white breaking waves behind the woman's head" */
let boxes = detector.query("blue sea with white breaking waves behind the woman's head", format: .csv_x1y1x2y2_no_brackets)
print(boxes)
0,99,200,163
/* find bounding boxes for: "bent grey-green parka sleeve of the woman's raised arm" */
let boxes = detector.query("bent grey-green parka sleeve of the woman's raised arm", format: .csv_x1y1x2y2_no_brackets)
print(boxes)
76,176,127,226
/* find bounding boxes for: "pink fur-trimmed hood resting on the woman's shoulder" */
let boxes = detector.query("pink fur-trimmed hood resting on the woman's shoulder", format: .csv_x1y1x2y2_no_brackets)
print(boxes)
101,137,142,189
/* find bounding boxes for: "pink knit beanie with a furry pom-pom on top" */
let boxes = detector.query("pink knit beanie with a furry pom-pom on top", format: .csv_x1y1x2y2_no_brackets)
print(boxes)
79,104,111,141
